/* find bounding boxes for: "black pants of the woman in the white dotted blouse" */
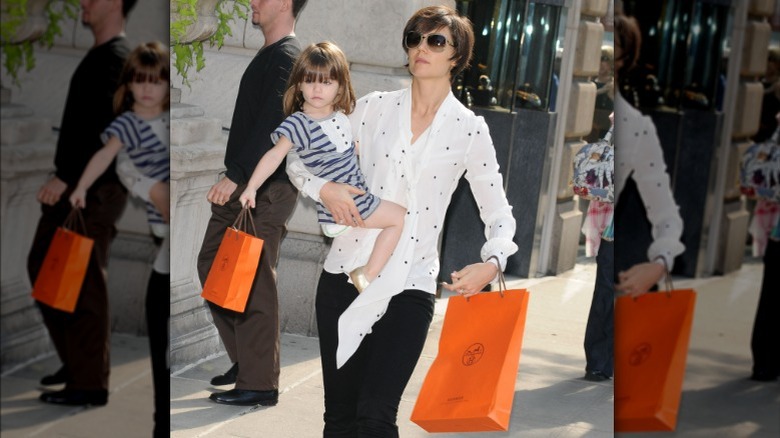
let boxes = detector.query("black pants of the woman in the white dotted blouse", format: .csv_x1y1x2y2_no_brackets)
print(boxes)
316,271,434,438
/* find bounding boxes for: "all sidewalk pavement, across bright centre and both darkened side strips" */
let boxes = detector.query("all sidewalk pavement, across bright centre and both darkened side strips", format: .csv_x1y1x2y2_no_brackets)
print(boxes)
0,255,780,438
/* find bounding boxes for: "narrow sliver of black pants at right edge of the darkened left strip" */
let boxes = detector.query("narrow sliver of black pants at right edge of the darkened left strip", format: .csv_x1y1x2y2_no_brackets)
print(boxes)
146,271,171,438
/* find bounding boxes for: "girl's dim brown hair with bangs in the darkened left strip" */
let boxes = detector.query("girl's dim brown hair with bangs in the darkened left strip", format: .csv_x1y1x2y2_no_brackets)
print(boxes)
114,41,171,114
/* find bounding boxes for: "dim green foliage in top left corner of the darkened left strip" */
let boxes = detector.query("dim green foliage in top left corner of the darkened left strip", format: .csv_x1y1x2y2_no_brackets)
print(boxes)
0,0,79,86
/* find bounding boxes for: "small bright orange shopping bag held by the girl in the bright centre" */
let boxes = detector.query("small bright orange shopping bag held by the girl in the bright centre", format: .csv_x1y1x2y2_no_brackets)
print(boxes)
200,207,263,312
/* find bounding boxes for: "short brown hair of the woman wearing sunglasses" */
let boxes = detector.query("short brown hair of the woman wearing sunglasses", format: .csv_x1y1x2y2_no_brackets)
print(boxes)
401,6,474,80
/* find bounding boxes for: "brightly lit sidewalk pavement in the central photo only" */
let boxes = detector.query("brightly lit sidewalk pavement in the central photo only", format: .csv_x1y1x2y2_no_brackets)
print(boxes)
171,261,613,438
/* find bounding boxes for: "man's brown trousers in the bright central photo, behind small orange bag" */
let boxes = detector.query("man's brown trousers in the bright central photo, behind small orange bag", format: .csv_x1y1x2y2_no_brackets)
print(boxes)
198,181,298,391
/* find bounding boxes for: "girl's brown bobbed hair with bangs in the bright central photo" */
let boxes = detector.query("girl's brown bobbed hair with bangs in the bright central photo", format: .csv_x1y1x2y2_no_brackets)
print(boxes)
283,41,356,116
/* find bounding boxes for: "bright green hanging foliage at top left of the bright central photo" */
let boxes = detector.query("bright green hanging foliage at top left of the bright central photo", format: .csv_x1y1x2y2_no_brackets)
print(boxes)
171,0,250,86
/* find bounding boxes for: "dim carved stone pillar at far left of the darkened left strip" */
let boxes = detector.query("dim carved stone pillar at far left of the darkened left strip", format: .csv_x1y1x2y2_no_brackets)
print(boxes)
0,93,54,372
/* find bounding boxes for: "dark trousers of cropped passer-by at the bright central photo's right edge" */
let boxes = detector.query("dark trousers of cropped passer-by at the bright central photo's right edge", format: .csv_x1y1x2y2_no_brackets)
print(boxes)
584,239,615,377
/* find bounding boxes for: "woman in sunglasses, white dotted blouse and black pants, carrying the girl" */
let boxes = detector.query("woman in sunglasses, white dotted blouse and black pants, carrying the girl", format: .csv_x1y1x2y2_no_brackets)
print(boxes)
287,6,517,437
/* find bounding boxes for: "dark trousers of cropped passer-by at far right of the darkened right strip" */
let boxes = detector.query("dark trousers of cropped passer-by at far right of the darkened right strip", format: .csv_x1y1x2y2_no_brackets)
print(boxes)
750,239,780,376
